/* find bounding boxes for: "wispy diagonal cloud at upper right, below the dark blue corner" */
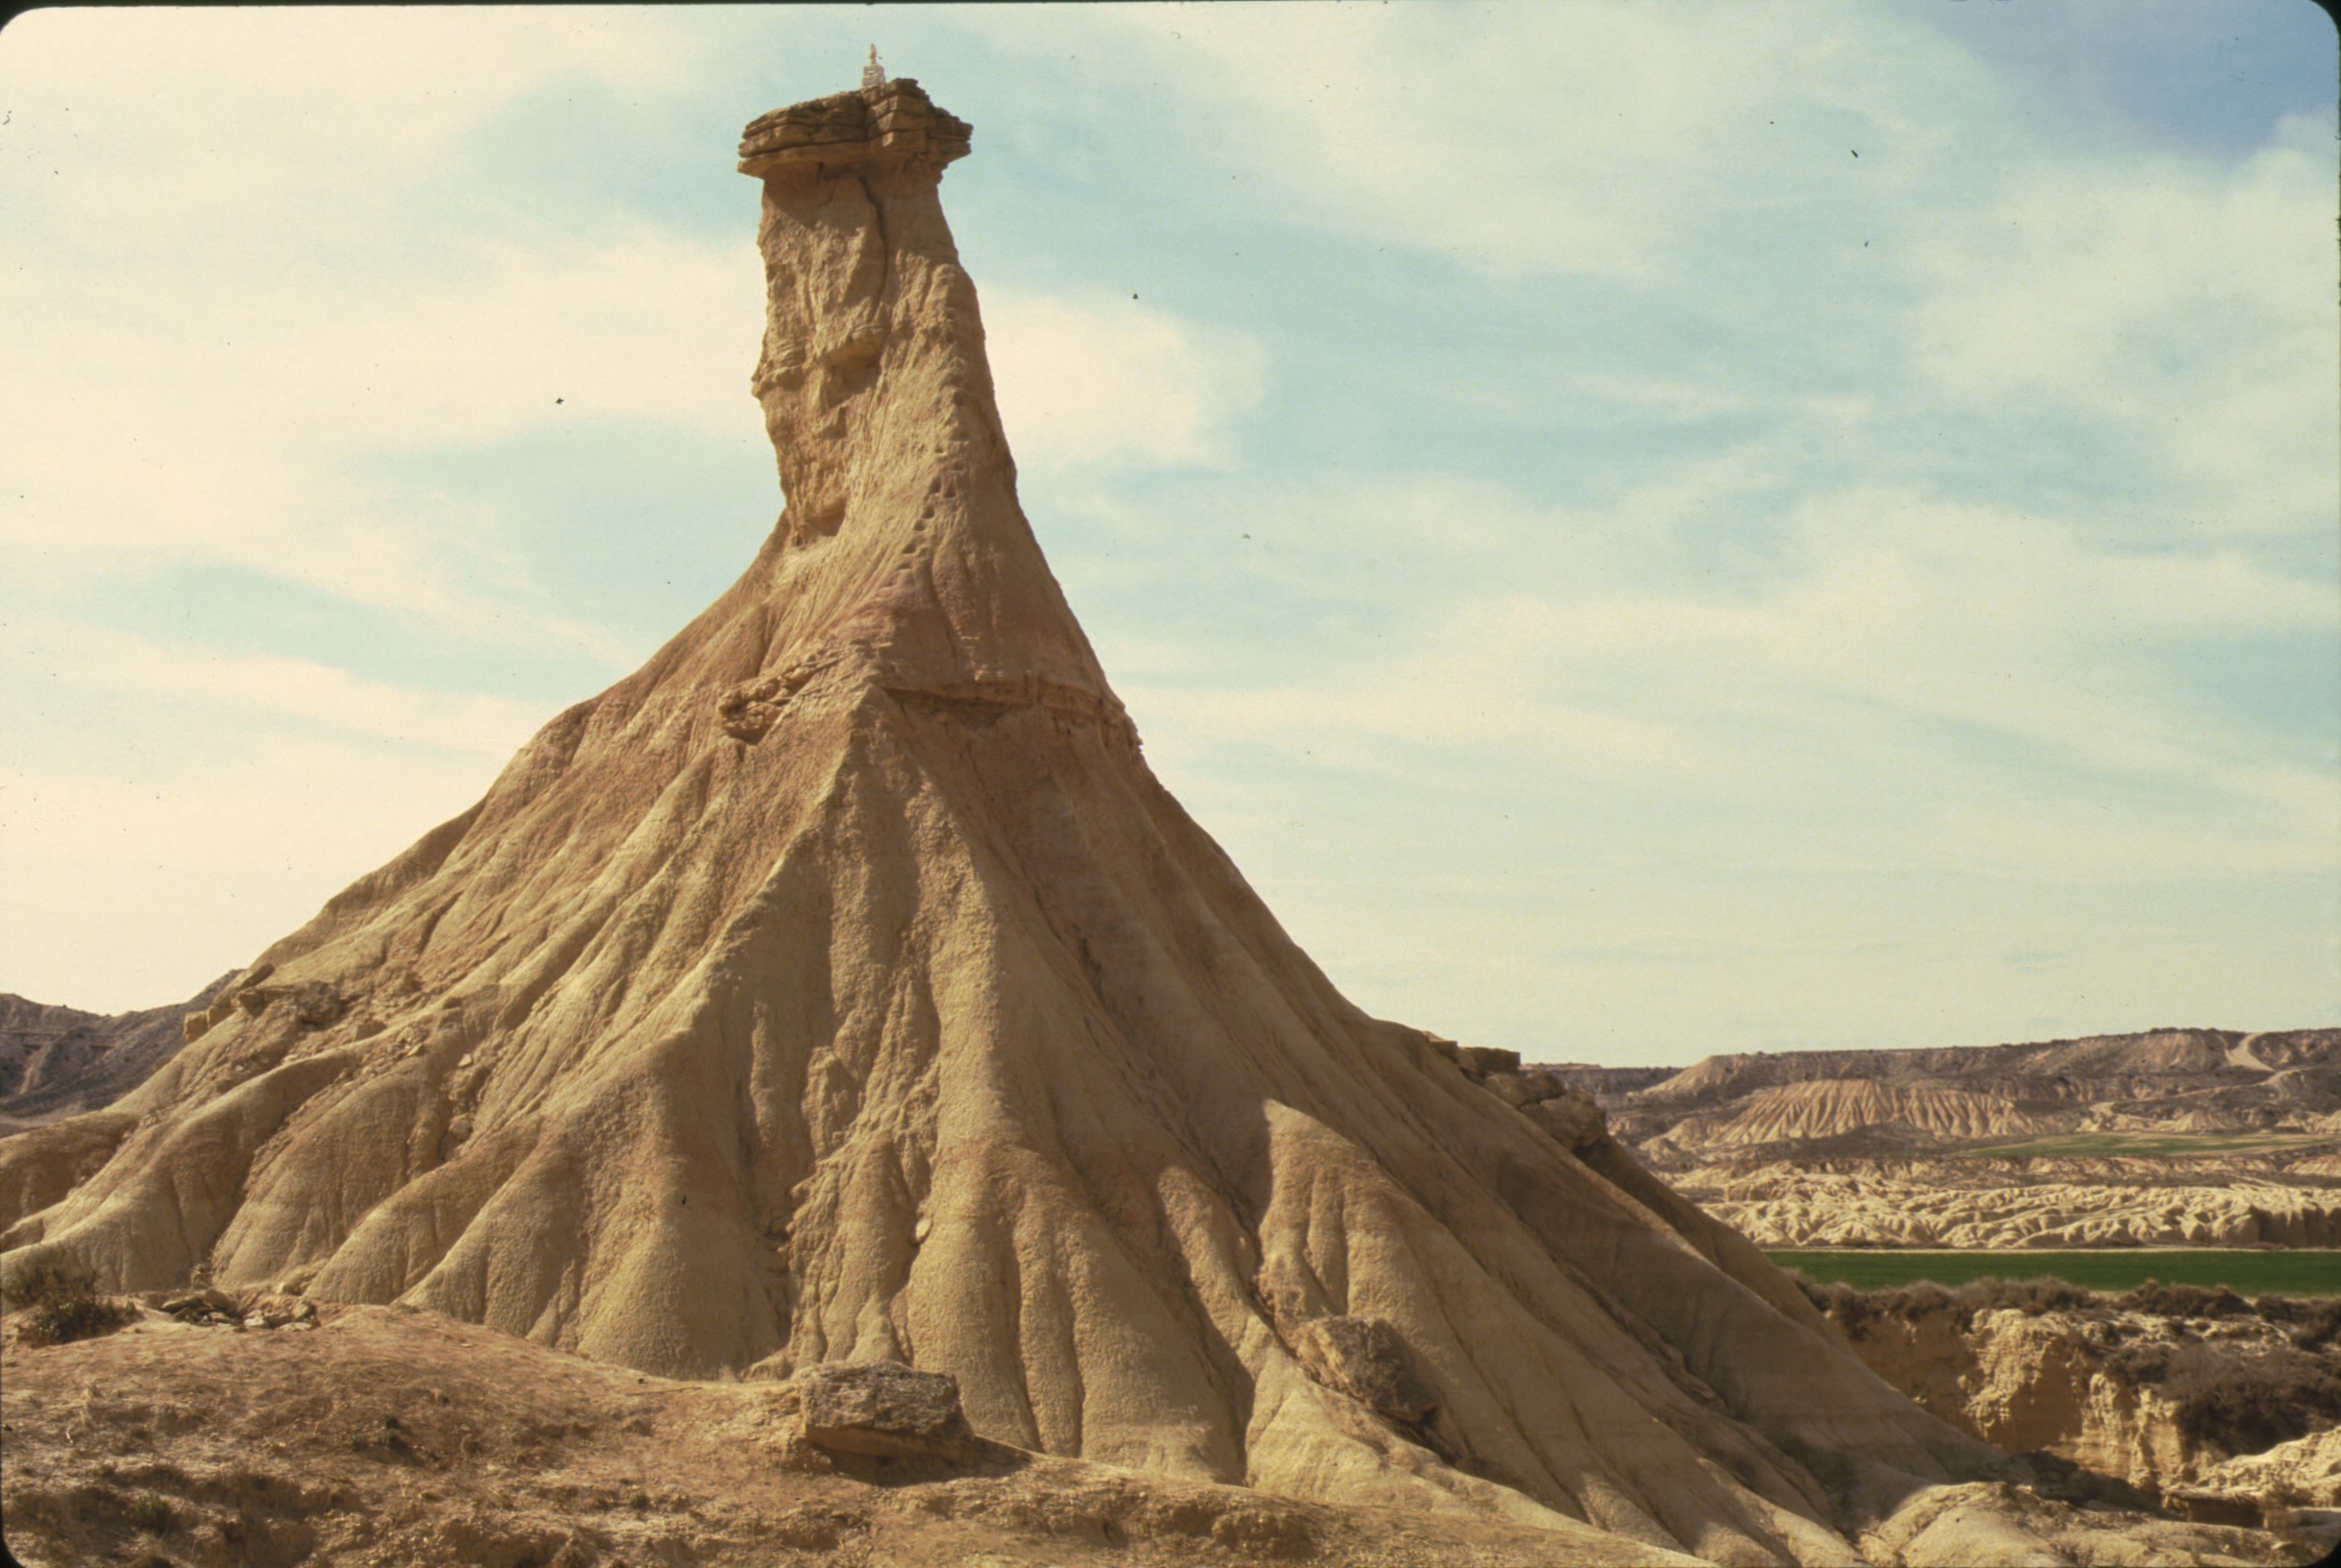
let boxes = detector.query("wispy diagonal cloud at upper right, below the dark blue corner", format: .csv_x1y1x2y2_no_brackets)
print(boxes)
1034,0,2341,536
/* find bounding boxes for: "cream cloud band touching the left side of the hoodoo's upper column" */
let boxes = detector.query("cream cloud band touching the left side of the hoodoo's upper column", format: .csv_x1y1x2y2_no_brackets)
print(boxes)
0,227,760,617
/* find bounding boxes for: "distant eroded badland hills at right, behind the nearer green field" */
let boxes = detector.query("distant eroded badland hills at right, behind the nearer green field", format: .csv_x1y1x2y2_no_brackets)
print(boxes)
1529,1029,2341,1250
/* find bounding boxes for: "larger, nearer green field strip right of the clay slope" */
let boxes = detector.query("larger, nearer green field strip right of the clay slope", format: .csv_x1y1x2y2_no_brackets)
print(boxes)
1765,1247,2341,1296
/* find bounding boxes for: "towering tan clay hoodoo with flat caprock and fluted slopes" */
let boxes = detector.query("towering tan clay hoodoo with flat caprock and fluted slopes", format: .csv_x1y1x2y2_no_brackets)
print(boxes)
0,82,1994,1561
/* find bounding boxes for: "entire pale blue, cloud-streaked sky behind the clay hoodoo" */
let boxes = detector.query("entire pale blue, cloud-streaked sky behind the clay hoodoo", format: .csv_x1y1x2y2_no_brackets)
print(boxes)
0,0,2341,1063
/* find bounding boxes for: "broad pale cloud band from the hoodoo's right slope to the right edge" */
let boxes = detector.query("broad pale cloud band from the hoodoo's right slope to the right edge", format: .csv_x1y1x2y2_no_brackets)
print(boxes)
1128,477,2341,876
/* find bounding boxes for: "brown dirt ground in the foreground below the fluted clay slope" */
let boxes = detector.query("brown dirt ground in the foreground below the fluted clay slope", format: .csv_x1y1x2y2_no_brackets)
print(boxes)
0,1306,1723,1568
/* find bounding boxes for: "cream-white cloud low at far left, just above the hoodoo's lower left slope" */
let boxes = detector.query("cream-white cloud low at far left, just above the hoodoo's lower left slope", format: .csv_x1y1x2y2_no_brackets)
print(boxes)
0,620,550,1011
